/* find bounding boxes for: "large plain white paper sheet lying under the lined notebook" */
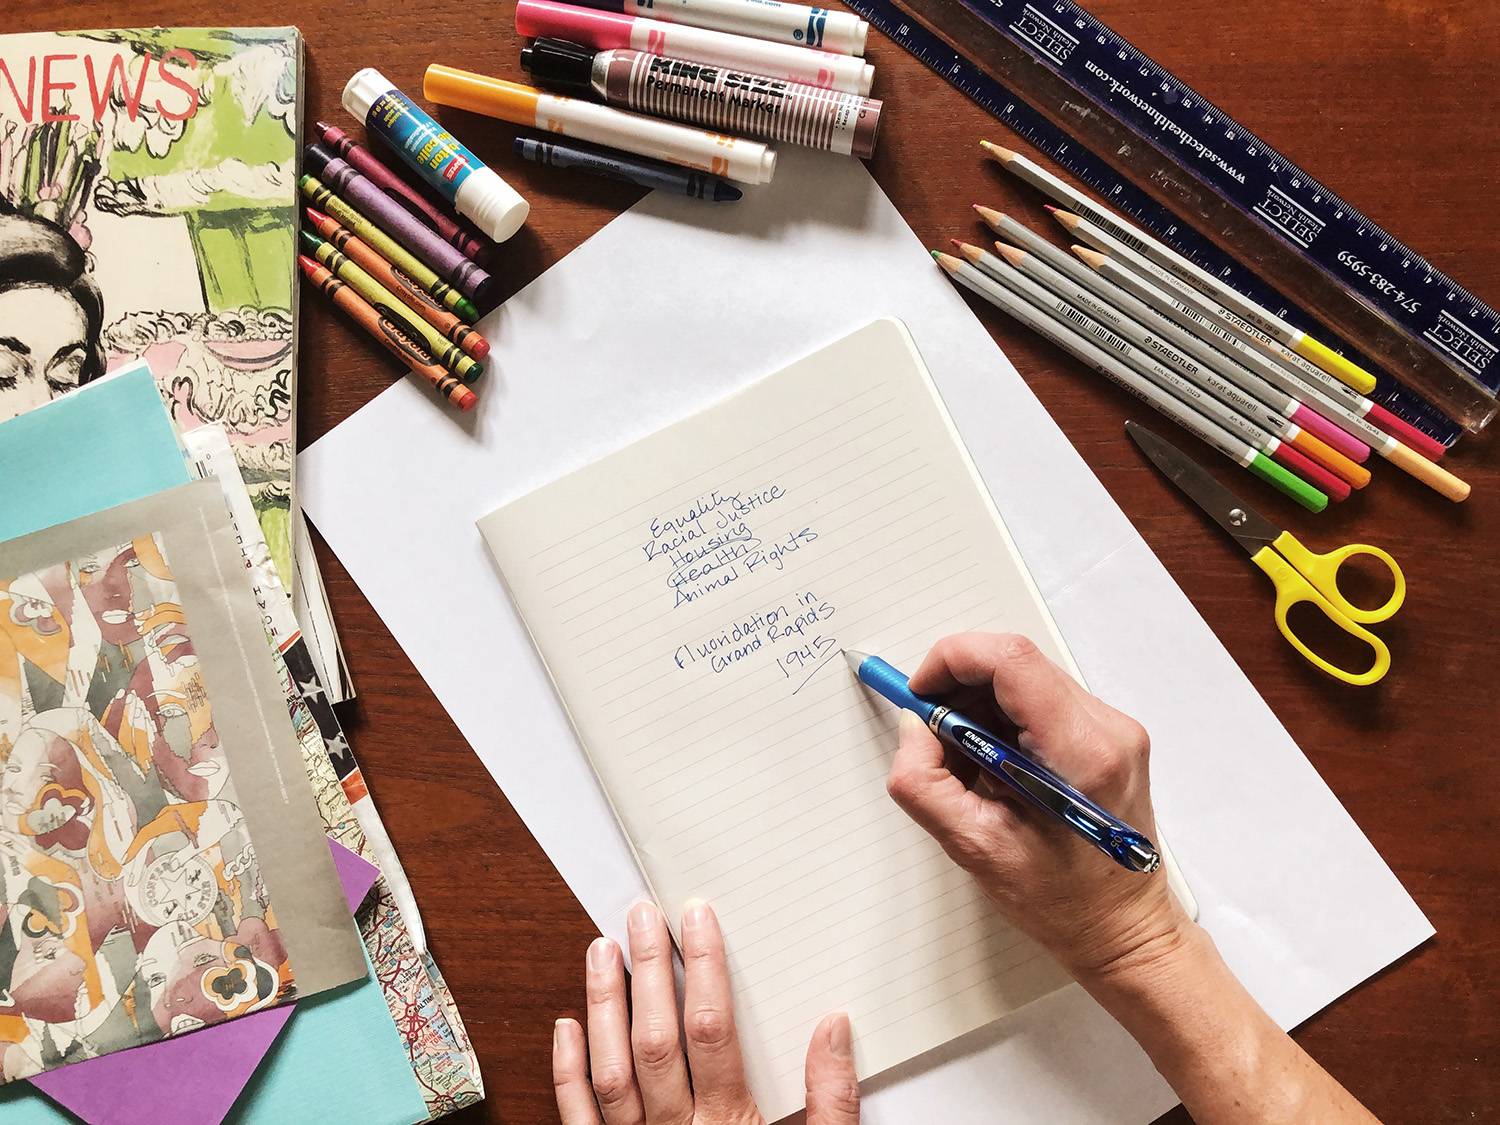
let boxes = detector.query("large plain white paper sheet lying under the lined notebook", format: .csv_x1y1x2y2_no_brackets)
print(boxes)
300,149,1433,1125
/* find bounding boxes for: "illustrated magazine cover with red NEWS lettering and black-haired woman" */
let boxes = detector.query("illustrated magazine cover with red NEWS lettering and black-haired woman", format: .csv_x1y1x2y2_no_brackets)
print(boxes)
0,27,302,588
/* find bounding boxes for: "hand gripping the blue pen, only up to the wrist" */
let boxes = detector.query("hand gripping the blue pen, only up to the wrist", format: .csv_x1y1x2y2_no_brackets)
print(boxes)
887,633,1188,978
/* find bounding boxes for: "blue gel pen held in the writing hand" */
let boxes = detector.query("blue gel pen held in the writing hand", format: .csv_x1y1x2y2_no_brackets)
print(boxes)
845,650,1161,872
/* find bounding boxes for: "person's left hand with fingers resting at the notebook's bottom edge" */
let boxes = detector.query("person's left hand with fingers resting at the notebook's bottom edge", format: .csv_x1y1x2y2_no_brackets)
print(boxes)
552,902,860,1125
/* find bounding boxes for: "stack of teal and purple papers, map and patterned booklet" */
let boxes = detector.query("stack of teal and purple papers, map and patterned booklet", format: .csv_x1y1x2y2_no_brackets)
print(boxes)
0,365,482,1125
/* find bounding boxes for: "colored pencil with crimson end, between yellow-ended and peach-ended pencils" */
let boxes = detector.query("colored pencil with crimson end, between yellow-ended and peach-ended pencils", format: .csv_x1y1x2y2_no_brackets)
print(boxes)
1047,204,1448,461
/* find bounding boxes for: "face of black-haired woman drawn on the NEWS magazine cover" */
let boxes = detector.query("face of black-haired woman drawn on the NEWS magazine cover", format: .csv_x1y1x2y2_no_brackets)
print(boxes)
0,285,89,419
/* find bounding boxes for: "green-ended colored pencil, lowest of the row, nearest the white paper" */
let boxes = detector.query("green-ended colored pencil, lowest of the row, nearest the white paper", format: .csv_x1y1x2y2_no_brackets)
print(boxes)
933,251,1328,512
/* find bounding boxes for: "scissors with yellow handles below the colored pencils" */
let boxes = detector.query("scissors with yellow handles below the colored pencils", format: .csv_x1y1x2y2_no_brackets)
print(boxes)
1125,422,1406,687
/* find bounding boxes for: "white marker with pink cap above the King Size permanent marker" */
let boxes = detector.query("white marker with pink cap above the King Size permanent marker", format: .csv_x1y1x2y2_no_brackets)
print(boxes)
516,0,875,95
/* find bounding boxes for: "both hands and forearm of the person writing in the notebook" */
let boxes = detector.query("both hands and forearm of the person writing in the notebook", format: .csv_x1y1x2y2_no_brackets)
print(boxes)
552,633,1373,1125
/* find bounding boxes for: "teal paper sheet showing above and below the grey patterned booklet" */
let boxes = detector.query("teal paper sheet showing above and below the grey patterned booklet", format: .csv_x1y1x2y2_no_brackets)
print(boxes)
0,363,428,1125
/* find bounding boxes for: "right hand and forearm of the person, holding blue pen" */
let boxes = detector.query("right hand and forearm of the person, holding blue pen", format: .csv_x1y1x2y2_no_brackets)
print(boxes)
882,633,1374,1122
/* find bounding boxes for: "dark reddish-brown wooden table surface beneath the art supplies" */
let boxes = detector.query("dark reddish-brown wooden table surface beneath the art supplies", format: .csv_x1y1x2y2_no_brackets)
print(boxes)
14,0,1500,1124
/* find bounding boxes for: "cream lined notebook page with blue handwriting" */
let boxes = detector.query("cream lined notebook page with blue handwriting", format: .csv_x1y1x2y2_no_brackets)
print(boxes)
480,320,1104,1121
